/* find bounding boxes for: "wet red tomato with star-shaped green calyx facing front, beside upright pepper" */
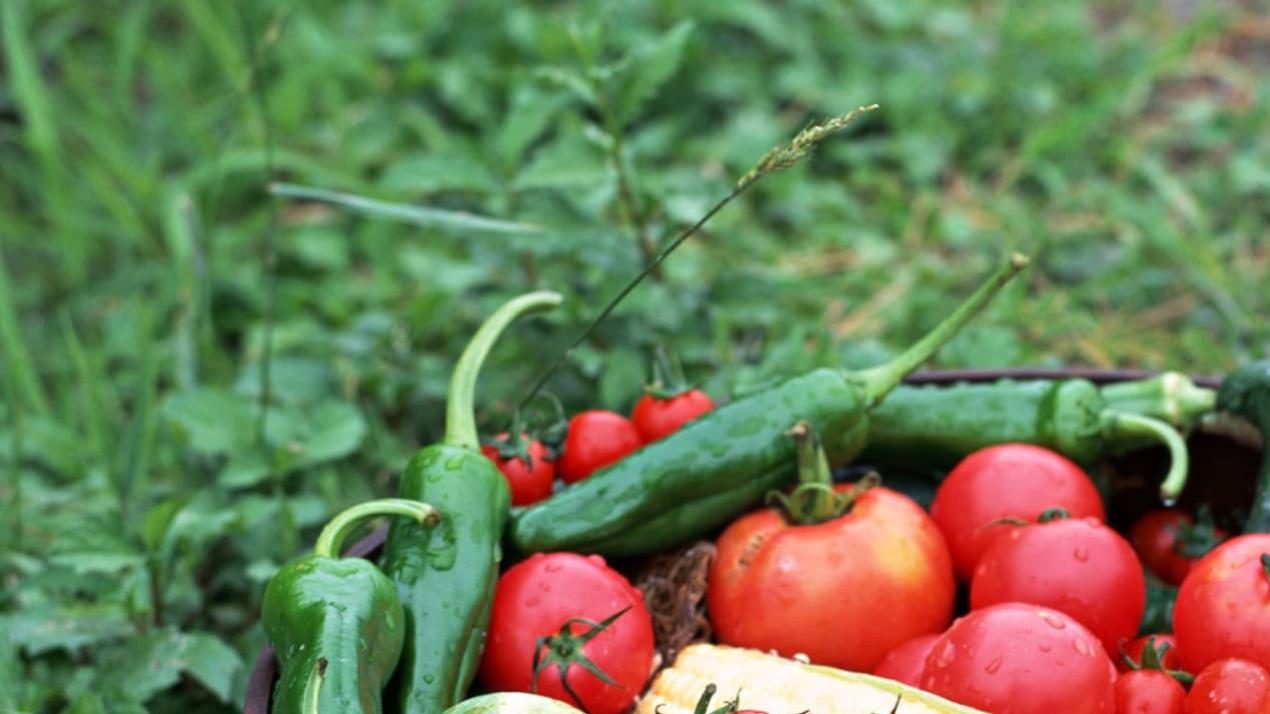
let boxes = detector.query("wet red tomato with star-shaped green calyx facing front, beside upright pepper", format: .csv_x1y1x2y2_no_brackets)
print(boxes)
480,553,653,714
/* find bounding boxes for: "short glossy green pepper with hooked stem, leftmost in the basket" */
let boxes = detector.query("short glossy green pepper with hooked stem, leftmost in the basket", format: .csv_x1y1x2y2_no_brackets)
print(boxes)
262,498,441,714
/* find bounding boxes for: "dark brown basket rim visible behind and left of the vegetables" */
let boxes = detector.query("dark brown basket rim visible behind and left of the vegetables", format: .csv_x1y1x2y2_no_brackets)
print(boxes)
243,367,1222,714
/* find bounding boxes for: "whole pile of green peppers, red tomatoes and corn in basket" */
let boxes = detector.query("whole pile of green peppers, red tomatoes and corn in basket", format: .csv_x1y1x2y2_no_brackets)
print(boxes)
255,113,1270,714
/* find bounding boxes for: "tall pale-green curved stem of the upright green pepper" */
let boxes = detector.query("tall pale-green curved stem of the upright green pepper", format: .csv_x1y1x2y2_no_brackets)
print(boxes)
446,290,561,451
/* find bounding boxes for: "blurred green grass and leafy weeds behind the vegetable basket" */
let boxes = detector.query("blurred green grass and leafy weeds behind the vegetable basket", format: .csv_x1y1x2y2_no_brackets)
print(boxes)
0,0,1270,713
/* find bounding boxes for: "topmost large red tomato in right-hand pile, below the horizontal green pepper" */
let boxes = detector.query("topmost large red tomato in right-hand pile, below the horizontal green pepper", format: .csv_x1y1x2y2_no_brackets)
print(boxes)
931,443,1106,581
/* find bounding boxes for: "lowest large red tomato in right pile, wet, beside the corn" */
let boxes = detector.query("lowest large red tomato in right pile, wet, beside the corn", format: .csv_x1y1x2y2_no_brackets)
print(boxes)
921,602,1115,714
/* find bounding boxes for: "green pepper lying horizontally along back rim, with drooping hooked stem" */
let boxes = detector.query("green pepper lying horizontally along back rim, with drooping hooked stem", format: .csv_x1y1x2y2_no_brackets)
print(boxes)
861,372,1217,501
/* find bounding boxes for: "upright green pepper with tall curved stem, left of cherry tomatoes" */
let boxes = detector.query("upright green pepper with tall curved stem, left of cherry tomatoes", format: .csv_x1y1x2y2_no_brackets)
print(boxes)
382,292,560,714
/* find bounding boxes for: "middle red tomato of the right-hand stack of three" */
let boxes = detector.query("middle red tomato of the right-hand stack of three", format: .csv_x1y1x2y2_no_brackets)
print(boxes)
970,518,1147,653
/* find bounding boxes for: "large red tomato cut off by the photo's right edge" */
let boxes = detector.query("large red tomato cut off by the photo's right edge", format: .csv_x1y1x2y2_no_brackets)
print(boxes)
1173,534,1270,672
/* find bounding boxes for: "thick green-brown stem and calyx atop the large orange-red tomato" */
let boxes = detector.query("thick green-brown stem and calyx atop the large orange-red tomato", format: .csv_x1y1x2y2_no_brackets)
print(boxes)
767,422,880,525
